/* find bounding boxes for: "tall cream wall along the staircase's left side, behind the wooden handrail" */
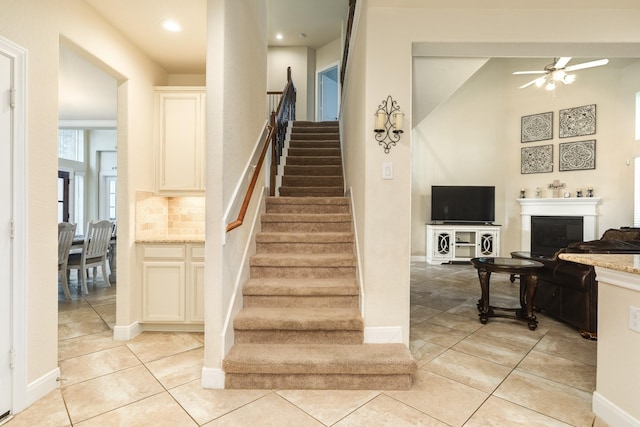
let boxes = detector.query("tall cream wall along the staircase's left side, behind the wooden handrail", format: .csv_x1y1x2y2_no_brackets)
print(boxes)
203,0,266,382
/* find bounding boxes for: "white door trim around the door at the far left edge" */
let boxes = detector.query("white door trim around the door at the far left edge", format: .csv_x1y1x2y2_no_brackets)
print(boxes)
0,37,32,413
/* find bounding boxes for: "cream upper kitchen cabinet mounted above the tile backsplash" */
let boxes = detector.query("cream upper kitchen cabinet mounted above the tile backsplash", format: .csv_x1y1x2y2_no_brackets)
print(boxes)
155,86,205,194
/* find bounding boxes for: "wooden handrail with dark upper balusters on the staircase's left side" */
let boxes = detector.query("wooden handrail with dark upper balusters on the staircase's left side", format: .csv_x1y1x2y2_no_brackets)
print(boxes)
226,67,295,233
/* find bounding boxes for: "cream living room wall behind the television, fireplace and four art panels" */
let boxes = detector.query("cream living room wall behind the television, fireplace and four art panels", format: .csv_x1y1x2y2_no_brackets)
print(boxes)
412,58,640,256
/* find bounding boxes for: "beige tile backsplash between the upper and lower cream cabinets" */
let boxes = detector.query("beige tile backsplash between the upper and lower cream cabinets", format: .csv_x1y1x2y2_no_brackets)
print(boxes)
136,191,205,239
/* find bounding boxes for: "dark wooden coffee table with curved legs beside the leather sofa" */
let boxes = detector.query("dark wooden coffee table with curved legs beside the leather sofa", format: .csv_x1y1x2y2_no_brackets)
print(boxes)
471,258,543,331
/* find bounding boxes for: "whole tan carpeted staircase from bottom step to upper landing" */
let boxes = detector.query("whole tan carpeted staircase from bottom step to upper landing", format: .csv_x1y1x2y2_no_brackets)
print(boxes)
223,122,416,390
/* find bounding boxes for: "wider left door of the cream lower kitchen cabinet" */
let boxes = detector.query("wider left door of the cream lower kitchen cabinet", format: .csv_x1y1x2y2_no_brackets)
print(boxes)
142,261,186,322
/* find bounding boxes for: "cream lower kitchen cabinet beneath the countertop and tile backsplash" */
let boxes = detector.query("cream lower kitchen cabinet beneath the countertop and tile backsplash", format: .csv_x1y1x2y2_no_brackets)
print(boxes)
138,243,204,331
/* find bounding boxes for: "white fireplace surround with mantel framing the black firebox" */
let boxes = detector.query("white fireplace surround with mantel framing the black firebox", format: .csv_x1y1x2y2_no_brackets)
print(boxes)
517,197,601,251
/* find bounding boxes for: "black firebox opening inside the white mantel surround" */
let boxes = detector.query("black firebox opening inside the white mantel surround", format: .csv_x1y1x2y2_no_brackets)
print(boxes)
531,216,584,258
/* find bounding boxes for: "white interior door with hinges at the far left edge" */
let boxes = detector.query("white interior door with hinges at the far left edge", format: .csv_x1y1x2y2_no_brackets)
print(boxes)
0,47,13,421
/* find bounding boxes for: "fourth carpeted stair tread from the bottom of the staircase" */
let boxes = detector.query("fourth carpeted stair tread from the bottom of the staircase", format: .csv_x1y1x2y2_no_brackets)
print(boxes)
250,253,356,268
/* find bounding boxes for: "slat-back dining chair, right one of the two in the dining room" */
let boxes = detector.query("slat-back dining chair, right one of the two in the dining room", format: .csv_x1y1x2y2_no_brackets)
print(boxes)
68,220,113,295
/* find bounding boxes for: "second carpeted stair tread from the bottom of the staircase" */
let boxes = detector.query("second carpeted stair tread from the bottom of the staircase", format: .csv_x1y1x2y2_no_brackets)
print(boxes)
233,307,364,332
